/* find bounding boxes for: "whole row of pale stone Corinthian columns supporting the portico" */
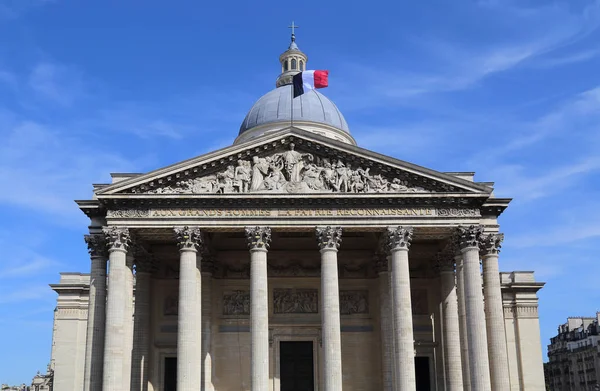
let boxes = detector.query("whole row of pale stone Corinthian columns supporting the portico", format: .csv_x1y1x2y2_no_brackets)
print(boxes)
79,226,510,391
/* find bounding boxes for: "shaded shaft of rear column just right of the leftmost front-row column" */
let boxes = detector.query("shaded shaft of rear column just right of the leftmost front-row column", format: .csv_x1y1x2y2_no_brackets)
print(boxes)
131,267,151,391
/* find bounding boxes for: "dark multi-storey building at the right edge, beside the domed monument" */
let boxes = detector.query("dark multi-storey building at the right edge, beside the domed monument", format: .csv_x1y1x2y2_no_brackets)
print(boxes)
545,312,600,391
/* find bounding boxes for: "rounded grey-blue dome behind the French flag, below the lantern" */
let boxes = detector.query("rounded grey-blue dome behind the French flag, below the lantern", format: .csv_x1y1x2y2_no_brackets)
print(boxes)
238,84,354,144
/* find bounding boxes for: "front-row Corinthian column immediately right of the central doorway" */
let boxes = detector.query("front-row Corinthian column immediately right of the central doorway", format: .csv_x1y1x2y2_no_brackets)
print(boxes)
316,227,342,391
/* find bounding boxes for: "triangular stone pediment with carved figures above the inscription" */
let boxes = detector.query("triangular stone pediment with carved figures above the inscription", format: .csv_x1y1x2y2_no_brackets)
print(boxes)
96,128,492,198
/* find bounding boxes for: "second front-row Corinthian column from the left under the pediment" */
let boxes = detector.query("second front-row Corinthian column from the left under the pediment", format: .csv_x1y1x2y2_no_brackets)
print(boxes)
174,227,202,391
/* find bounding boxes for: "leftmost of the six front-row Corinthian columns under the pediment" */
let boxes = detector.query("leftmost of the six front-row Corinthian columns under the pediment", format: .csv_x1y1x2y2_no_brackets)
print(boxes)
102,227,131,391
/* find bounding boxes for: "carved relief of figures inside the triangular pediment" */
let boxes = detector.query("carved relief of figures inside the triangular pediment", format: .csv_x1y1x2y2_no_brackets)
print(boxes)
141,143,429,194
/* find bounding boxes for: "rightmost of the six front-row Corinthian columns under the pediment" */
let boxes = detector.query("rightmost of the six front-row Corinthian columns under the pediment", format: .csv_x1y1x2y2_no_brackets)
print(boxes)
458,225,491,391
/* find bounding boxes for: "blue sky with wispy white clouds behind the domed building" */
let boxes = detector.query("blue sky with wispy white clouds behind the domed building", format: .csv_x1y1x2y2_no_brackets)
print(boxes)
0,0,600,383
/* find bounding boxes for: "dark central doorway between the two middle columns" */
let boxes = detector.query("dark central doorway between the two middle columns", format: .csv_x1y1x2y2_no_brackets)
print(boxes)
279,341,315,391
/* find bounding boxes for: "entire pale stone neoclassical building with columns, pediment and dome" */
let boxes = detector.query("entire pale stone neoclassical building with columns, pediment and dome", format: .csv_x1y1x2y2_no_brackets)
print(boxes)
51,38,544,391
